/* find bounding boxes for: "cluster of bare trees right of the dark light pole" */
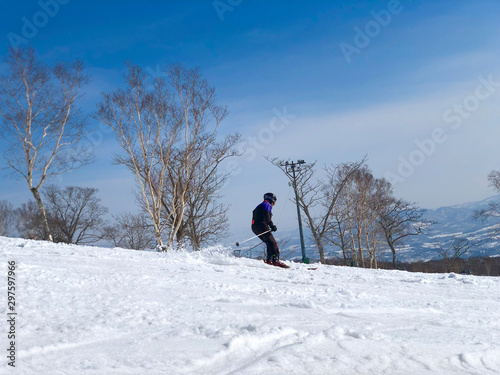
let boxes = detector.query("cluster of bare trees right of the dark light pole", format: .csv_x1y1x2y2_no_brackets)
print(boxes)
271,159,431,268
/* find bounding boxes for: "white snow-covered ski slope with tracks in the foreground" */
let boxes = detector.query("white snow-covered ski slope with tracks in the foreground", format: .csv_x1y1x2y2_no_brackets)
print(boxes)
0,237,500,375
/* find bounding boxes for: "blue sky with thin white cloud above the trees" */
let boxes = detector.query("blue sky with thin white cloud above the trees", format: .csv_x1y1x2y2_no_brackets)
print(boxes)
0,0,500,238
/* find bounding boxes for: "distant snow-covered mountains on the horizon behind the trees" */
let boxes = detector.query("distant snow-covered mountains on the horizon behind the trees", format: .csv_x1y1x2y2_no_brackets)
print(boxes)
227,195,500,262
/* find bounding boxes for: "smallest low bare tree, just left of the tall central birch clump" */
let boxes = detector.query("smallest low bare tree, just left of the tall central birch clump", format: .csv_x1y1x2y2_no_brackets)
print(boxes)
103,213,155,250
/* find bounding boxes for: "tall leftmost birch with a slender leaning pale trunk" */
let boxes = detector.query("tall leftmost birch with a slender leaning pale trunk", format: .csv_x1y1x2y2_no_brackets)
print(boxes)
0,48,92,240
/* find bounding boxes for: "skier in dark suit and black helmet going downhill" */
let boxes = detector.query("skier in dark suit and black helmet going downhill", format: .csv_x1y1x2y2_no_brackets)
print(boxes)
252,193,289,268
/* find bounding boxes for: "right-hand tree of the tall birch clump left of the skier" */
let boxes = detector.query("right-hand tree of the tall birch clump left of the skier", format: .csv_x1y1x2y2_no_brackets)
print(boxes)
163,65,241,248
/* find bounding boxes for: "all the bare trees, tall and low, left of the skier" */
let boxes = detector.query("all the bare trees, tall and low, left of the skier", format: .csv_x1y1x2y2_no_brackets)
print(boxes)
0,49,240,250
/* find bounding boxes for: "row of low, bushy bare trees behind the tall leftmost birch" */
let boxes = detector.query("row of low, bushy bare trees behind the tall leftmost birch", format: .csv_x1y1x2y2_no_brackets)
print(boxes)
0,191,160,250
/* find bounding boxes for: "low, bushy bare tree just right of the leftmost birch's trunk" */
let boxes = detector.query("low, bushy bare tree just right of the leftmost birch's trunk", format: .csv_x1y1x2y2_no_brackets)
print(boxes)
43,185,108,244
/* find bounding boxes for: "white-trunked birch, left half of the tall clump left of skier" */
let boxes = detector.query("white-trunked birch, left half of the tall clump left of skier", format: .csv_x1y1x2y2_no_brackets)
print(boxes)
94,64,181,250
